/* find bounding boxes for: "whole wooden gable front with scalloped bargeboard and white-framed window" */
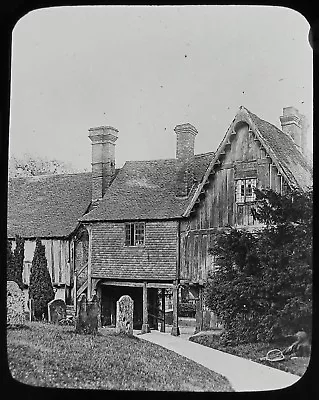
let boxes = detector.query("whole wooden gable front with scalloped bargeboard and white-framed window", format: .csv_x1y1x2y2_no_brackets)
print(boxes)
181,104,288,283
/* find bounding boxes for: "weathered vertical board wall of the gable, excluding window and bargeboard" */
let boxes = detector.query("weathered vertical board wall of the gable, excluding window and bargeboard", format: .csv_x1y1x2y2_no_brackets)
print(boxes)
180,123,285,283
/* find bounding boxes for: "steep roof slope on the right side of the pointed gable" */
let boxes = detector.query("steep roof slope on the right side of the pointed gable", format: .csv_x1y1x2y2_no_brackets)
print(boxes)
246,109,312,188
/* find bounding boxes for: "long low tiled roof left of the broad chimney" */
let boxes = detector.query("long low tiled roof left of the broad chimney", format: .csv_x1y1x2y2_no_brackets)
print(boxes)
7,172,92,238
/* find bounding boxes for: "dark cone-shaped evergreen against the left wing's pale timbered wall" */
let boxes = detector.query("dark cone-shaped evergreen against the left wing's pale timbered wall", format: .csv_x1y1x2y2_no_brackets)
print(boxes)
29,238,54,319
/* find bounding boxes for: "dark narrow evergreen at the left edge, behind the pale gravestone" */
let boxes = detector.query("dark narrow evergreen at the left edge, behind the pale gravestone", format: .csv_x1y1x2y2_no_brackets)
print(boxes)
7,235,24,290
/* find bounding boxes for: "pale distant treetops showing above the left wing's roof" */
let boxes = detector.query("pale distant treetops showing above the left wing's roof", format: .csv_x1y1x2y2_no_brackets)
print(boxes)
9,153,85,178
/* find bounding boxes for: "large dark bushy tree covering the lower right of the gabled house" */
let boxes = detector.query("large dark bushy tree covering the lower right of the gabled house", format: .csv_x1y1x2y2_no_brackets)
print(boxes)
205,189,312,342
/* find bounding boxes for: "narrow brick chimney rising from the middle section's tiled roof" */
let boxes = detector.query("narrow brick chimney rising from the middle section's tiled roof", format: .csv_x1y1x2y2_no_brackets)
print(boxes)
174,123,198,197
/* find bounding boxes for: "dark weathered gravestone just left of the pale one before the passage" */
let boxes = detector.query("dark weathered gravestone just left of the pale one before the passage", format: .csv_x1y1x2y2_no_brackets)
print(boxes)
75,293,99,335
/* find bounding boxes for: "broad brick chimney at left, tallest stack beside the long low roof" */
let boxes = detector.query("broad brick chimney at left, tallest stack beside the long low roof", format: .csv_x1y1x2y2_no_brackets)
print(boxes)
89,126,118,201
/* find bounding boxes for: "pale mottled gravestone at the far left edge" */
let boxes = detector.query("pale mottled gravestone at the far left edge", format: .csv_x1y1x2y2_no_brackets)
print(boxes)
7,281,25,326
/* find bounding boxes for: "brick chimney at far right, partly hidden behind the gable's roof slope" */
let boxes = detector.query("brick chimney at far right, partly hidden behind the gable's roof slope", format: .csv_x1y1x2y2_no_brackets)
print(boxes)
280,107,308,153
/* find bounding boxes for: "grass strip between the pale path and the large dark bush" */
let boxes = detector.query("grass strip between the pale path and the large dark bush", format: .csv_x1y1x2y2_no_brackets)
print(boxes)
189,333,310,376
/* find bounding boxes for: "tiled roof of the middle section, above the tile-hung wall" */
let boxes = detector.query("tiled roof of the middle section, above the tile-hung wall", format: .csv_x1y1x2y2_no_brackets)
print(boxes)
81,153,214,221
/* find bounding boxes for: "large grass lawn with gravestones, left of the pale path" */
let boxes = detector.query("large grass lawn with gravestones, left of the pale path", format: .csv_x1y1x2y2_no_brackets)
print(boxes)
7,322,233,392
